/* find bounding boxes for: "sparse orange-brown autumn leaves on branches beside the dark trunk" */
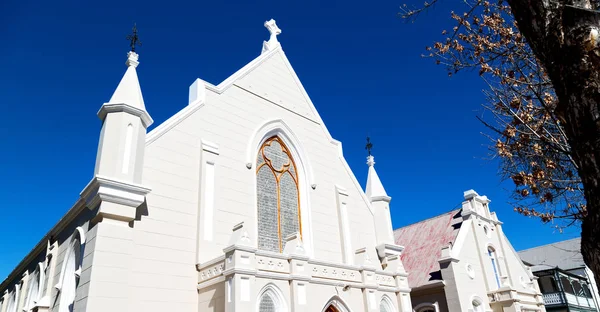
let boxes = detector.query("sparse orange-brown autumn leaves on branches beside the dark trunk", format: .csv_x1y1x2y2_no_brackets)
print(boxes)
400,0,586,229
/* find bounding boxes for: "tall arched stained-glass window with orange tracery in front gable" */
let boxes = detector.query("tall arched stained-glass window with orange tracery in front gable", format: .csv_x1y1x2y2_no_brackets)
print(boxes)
256,136,302,252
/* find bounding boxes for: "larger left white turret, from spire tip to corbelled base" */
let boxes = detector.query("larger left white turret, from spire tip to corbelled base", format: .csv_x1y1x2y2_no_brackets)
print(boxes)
82,47,152,222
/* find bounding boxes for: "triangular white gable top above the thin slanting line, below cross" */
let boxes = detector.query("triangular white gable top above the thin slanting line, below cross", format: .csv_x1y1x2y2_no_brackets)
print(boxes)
233,48,320,122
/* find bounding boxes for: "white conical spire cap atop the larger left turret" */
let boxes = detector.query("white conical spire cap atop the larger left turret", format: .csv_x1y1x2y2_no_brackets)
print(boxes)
98,51,153,128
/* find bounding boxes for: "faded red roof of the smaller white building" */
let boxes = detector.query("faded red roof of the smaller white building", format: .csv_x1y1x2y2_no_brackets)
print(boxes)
394,209,462,288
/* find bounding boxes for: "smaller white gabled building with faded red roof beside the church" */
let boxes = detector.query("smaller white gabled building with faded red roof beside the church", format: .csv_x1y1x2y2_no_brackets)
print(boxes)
394,190,545,312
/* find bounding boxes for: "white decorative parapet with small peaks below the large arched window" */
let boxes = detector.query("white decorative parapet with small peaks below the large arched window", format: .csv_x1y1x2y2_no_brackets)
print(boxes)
196,224,410,292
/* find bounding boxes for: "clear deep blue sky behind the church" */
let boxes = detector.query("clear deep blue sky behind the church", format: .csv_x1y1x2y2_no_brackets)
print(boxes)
0,0,579,279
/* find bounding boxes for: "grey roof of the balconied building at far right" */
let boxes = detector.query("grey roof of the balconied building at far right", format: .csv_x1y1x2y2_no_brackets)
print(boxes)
519,238,585,272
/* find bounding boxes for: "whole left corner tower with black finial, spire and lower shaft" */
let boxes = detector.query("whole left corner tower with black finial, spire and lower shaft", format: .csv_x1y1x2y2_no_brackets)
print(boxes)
78,26,152,312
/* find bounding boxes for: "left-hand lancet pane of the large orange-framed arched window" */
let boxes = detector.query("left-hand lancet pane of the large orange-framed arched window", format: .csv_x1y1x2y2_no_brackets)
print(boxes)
256,166,279,252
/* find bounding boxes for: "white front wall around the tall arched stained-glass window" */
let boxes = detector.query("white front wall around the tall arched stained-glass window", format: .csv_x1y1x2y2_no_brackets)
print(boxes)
144,47,375,262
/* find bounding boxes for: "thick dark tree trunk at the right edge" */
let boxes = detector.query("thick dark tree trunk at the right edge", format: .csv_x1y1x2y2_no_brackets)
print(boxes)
507,0,600,287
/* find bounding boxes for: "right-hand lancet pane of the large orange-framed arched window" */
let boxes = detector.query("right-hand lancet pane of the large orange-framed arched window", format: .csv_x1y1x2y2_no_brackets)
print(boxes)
279,173,299,242
